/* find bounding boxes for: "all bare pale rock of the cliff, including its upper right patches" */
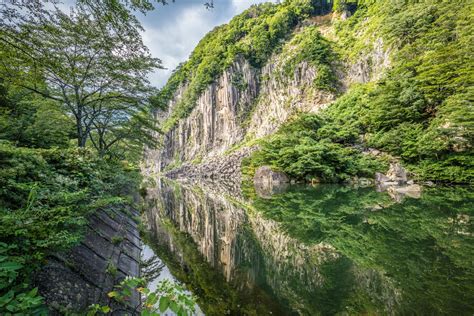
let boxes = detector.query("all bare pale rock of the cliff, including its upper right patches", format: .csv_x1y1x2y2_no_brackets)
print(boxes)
145,4,390,176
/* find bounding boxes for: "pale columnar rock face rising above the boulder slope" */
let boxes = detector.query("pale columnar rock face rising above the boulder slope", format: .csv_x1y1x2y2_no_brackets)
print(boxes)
145,55,334,173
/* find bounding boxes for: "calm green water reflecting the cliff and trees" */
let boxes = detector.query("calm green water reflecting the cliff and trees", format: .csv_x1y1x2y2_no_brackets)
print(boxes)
146,181,474,315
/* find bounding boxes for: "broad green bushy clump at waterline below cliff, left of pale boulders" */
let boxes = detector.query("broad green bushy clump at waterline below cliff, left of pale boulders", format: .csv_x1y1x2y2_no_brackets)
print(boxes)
250,114,383,182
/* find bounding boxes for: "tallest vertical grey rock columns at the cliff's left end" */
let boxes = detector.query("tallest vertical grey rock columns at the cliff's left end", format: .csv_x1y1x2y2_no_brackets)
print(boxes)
147,59,258,172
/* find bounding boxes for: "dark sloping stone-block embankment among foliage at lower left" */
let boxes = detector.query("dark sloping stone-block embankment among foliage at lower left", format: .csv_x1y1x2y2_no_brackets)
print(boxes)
34,206,141,315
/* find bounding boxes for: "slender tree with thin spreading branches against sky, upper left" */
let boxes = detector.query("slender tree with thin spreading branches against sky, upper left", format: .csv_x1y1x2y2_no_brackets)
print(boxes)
0,6,160,151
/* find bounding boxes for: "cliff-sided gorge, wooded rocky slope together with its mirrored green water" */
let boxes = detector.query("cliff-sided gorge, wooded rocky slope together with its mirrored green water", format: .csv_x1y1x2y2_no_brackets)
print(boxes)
143,1,473,315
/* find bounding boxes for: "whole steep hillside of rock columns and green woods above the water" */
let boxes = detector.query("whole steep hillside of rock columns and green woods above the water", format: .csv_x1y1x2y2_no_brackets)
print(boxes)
144,0,473,183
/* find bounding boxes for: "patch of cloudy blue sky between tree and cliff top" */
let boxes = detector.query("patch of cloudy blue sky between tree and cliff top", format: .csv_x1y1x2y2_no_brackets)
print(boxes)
137,0,275,88
